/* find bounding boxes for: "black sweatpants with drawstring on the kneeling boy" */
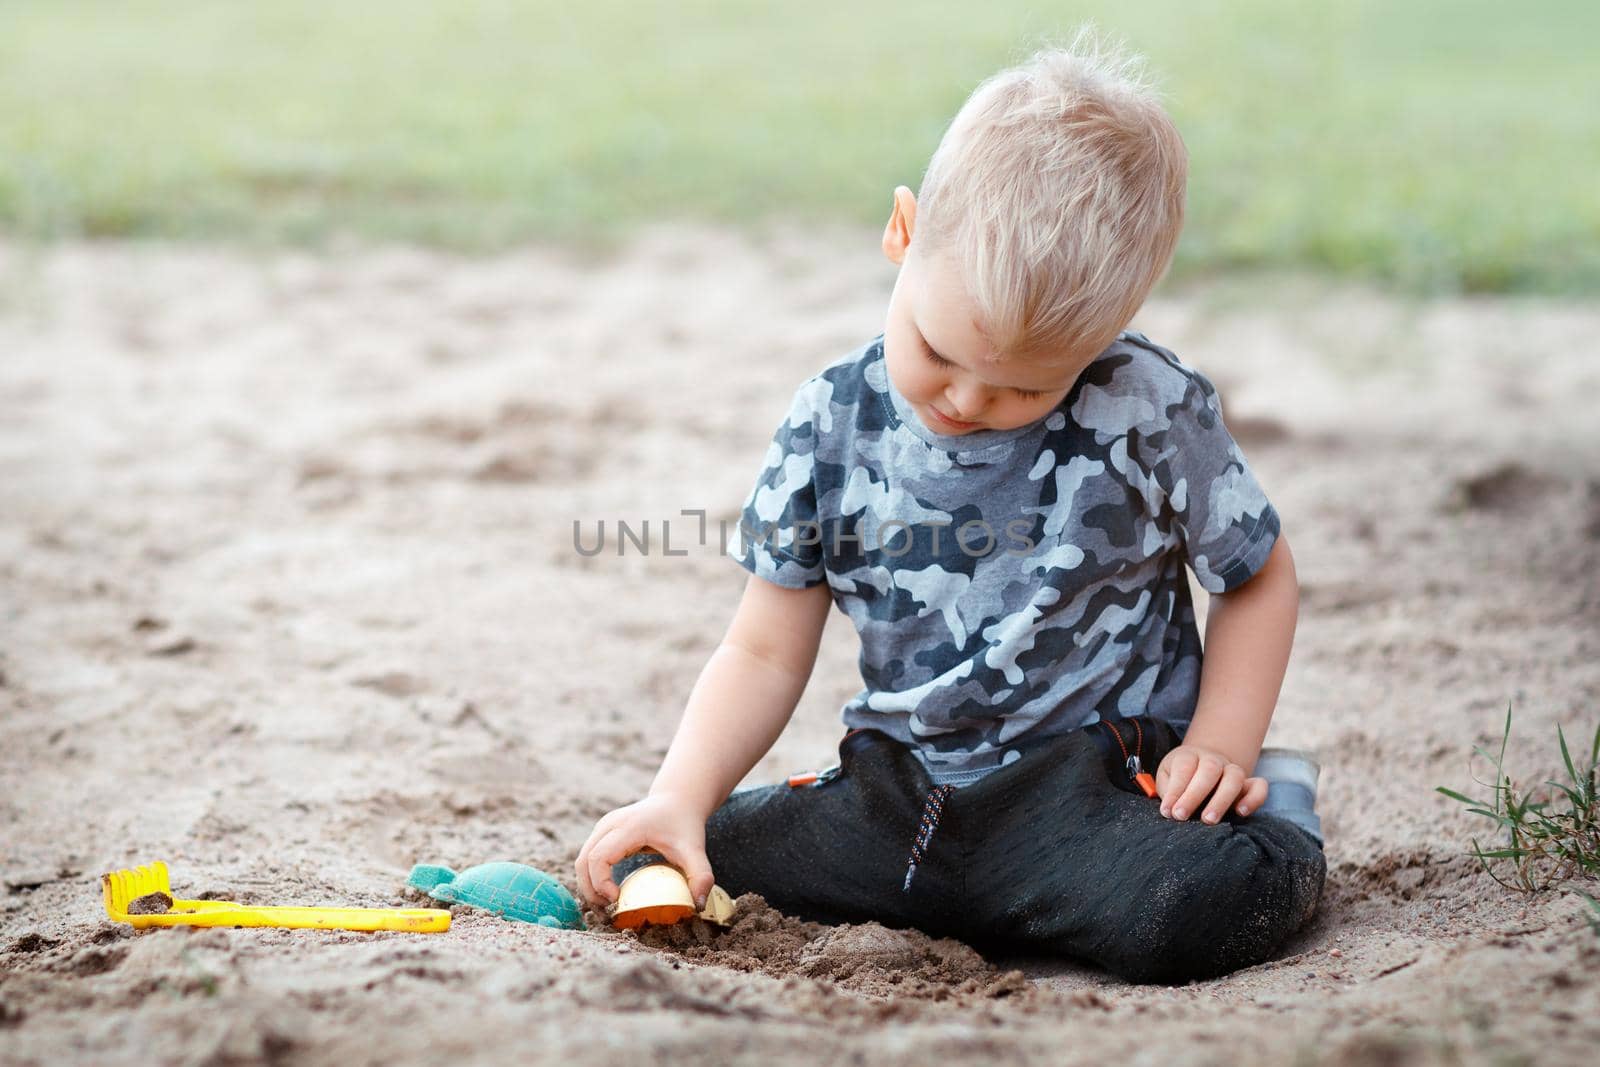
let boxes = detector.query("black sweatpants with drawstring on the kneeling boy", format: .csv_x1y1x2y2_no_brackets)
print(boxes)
691,717,1326,982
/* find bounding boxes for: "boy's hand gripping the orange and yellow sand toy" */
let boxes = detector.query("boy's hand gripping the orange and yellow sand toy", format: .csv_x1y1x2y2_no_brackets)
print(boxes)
573,795,712,907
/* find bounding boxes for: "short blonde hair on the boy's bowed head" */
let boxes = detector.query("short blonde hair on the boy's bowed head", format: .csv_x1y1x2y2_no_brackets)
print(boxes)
915,27,1189,357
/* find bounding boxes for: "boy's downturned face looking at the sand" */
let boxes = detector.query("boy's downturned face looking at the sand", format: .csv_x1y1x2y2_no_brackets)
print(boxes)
883,190,1093,435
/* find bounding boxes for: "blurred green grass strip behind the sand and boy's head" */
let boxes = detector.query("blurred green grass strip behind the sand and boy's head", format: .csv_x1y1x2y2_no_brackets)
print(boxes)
0,0,1600,293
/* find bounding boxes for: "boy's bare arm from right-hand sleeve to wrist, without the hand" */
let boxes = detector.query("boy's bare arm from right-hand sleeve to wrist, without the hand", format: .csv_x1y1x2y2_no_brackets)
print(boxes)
1184,536,1299,769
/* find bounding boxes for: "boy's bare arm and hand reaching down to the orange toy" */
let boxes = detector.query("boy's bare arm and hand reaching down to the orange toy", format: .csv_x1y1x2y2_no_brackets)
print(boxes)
574,574,832,904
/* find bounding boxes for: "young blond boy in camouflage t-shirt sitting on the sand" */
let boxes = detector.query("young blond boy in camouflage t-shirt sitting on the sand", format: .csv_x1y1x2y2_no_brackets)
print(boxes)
576,35,1325,981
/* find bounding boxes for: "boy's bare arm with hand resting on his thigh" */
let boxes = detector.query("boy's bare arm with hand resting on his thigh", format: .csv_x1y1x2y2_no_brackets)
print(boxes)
1155,534,1299,822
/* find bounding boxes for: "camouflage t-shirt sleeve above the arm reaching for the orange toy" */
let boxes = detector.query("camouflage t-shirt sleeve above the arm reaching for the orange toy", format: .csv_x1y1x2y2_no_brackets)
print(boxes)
728,387,827,589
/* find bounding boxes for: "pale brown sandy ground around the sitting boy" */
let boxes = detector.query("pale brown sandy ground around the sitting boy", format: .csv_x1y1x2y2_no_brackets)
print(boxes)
0,227,1600,1064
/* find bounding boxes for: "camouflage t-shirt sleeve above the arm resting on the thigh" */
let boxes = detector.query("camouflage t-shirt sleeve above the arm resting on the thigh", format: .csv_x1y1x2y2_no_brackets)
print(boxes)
1141,368,1278,593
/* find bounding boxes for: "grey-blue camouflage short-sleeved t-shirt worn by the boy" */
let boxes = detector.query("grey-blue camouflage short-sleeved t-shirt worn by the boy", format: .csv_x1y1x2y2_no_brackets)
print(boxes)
728,333,1278,785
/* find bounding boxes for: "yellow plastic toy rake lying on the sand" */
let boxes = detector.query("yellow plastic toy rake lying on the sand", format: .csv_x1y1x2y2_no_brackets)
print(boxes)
101,862,450,934
